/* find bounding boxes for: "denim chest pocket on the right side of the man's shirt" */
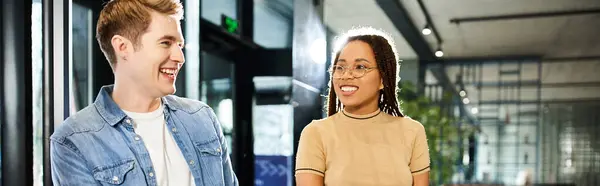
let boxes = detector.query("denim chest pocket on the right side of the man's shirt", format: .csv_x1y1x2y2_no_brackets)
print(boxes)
194,137,224,186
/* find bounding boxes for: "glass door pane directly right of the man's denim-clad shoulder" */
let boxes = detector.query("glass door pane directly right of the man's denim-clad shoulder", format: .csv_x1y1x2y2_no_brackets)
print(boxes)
201,52,234,154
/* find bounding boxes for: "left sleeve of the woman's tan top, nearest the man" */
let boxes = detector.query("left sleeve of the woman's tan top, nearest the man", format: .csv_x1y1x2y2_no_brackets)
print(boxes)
295,122,326,176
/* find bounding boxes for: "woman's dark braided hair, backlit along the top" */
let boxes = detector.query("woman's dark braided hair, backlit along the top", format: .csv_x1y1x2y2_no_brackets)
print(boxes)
327,27,404,117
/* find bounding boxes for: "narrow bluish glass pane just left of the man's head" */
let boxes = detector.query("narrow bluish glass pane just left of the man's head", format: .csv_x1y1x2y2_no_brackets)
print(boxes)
71,3,93,113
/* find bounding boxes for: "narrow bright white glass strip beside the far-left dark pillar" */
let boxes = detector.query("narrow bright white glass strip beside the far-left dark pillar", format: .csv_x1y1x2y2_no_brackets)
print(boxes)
31,0,44,186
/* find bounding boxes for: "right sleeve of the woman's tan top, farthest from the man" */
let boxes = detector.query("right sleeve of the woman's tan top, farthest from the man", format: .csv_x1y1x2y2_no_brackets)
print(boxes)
409,123,430,175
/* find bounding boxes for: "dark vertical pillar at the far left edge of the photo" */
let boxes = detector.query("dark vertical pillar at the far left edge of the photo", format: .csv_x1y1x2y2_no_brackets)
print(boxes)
0,0,33,185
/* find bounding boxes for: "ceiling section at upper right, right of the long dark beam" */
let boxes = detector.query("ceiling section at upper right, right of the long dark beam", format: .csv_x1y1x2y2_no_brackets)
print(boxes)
398,0,600,57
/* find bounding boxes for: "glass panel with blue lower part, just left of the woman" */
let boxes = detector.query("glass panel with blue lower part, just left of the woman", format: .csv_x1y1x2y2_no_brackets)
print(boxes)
252,76,294,186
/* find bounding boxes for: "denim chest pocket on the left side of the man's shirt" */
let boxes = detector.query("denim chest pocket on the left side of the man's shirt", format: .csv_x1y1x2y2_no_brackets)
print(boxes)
92,160,135,185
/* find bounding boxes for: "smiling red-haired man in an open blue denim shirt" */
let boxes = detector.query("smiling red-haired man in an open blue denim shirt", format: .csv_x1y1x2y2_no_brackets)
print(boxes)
50,0,238,186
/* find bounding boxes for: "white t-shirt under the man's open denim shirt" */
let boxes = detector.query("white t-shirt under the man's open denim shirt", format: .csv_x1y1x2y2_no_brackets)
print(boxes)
123,104,195,186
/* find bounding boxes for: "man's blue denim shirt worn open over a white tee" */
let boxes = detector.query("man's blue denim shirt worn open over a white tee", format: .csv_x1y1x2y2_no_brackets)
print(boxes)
50,85,238,186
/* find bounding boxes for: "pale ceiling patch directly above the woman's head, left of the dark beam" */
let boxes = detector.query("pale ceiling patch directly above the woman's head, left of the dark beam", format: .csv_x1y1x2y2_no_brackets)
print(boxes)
324,0,417,59
